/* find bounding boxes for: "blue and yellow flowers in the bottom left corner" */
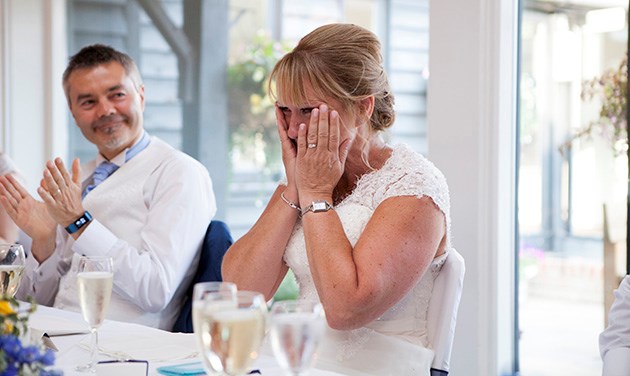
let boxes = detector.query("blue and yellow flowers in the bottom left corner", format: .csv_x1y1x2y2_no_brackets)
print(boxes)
0,296,61,376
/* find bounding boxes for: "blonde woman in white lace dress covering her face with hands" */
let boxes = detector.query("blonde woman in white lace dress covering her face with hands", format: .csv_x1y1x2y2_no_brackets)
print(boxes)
223,24,451,375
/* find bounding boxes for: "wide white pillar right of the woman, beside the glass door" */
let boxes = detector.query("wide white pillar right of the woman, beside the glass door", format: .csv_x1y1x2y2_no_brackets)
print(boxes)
428,0,516,376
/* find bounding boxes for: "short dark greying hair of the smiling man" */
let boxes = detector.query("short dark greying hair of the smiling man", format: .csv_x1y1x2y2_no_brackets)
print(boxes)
62,44,142,104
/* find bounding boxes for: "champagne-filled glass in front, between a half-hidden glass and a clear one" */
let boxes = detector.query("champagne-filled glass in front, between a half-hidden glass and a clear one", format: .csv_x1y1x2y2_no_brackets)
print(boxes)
200,291,267,376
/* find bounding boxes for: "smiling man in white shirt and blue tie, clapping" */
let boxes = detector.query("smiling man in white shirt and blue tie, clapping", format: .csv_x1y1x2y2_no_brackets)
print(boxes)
0,45,216,330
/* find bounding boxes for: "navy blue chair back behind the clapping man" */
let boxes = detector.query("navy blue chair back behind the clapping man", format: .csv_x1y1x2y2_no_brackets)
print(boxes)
172,220,234,333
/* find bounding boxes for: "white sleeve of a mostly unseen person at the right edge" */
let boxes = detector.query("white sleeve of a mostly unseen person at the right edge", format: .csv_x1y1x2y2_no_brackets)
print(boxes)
599,276,630,376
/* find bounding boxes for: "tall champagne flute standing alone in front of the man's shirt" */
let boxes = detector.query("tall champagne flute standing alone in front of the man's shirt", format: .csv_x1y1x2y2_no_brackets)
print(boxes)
77,256,114,373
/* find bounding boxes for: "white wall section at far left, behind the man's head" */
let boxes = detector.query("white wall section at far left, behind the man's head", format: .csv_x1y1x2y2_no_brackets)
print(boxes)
0,0,67,192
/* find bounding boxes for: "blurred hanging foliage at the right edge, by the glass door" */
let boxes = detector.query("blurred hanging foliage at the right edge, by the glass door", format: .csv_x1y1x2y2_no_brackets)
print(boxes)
560,54,628,156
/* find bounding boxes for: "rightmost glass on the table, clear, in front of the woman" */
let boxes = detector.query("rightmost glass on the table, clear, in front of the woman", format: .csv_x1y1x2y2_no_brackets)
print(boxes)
269,300,326,376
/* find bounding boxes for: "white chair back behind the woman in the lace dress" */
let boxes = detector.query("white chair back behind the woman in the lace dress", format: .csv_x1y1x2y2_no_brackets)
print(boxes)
427,249,466,376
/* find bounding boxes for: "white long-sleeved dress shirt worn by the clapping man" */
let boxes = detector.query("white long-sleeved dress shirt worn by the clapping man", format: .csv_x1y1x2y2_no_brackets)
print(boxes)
18,137,216,330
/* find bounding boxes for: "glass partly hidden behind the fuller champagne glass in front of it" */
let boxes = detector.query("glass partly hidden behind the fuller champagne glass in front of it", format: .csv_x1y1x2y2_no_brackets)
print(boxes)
192,282,236,370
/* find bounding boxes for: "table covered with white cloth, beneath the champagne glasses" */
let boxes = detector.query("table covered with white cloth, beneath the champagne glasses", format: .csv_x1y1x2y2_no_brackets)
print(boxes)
27,303,341,376
